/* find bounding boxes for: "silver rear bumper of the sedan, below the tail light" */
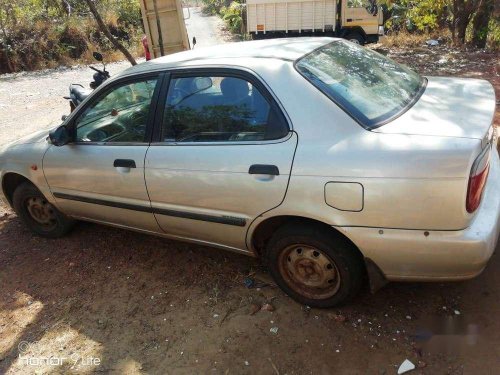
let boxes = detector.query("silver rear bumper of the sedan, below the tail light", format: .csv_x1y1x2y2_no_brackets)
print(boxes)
337,150,500,281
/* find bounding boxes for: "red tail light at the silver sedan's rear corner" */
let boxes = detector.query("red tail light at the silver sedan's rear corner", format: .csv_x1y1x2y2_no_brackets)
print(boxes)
465,145,490,213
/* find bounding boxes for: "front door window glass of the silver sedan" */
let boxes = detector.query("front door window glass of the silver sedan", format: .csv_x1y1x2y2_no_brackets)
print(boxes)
76,78,157,142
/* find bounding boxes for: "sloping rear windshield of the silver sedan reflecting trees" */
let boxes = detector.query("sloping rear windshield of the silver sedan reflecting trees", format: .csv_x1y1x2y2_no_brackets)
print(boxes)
295,41,425,129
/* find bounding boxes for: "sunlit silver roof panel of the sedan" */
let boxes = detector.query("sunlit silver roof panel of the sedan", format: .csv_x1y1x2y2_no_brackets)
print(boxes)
116,37,338,76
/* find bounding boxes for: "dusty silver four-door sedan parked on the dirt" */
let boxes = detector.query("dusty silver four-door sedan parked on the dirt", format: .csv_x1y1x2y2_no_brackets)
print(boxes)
0,38,500,307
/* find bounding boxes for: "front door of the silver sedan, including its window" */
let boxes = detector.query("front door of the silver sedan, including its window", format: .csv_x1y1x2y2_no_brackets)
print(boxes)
43,75,161,232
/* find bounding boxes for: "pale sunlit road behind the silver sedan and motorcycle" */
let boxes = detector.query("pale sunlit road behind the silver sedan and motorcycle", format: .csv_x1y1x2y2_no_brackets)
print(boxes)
0,8,224,145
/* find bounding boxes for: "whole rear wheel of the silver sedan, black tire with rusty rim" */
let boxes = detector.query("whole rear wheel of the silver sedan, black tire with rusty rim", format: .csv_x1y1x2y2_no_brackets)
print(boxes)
264,224,365,308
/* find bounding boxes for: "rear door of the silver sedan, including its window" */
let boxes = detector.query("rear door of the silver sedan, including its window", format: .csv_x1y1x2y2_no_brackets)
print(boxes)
145,69,297,251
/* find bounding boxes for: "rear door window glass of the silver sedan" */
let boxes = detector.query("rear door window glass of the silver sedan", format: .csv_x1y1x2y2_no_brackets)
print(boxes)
162,76,288,142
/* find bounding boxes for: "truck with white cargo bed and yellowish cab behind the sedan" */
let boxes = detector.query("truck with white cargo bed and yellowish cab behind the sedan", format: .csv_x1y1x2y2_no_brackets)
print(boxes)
247,0,384,44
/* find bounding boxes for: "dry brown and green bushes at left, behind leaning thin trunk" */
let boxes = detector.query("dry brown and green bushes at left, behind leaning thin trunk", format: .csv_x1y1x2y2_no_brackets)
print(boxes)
0,0,143,73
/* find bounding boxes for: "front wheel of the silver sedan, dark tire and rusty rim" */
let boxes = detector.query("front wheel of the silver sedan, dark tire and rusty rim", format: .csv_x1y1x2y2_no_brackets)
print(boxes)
12,182,75,238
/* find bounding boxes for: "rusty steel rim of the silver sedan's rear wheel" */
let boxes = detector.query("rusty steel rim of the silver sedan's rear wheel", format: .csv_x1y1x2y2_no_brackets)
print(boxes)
279,244,341,299
